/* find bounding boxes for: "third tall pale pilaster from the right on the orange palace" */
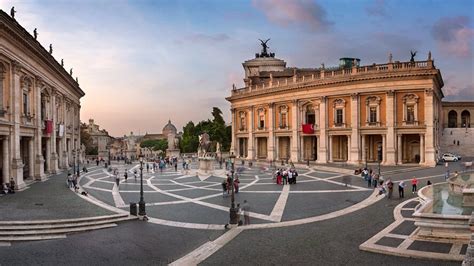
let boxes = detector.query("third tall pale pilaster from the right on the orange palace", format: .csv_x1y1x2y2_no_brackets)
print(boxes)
348,93,361,164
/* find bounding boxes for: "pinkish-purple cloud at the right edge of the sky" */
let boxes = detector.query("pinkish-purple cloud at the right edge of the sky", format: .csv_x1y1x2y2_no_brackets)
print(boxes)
431,16,474,57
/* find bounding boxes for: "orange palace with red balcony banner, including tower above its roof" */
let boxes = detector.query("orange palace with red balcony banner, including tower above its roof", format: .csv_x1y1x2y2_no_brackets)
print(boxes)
227,46,443,166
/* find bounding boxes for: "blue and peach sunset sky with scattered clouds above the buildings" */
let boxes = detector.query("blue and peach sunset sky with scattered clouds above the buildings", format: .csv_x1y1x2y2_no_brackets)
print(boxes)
0,0,474,136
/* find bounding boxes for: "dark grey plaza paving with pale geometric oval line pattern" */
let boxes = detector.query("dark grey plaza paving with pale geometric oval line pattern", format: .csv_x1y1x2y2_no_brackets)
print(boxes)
0,159,466,265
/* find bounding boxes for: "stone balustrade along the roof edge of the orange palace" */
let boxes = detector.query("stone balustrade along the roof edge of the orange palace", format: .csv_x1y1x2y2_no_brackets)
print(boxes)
232,60,435,96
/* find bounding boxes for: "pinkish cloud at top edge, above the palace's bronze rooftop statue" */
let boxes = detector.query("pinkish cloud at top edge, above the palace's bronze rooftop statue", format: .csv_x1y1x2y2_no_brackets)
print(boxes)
252,0,332,31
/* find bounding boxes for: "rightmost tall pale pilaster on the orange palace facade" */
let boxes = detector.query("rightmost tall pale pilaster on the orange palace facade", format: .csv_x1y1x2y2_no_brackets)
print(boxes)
420,88,436,167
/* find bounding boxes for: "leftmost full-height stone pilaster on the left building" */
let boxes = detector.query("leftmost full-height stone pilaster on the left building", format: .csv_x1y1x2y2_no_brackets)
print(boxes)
10,61,25,189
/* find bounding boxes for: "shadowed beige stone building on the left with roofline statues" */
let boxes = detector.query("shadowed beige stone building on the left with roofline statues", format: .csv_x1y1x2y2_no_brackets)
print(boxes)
0,10,84,188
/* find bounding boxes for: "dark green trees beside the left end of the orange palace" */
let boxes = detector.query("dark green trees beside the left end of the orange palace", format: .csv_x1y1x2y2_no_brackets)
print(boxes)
180,107,232,153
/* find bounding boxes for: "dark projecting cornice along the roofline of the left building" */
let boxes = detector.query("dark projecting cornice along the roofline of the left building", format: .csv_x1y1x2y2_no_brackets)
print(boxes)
0,10,85,97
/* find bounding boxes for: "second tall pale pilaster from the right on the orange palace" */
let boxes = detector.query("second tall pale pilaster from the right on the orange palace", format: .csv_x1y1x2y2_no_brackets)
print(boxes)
384,91,397,165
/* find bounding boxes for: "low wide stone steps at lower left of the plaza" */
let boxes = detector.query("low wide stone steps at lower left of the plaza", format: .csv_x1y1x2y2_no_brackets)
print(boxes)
0,214,137,242
